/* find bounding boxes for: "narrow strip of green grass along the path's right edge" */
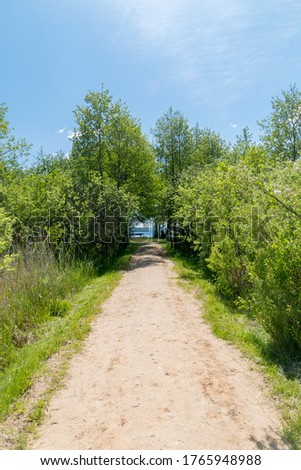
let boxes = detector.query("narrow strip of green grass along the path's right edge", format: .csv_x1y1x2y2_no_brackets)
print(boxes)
166,246,301,449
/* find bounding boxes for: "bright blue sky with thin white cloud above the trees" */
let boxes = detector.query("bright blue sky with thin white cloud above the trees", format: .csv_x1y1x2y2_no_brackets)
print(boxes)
0,0,301,158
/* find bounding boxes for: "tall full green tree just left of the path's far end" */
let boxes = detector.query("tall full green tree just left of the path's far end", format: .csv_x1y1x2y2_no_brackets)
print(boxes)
70,89,156,215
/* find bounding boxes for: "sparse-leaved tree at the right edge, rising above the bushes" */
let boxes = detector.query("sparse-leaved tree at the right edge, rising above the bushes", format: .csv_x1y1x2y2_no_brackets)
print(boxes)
258,84,301,161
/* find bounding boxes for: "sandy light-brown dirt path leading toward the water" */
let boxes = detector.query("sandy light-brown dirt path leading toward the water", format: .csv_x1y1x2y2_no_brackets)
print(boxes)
32,244,286,450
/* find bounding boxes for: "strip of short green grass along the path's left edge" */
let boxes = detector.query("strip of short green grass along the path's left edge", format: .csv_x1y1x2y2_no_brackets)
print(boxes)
0,245,136,438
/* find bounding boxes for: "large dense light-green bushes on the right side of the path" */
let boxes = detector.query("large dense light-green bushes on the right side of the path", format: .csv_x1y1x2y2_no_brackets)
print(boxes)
176,151,301,355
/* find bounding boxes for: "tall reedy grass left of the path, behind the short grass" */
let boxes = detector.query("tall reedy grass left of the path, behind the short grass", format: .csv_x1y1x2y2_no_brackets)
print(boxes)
0,245,94,371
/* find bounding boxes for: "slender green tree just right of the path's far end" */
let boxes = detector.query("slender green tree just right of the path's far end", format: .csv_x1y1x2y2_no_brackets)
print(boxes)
152,108,228,245
